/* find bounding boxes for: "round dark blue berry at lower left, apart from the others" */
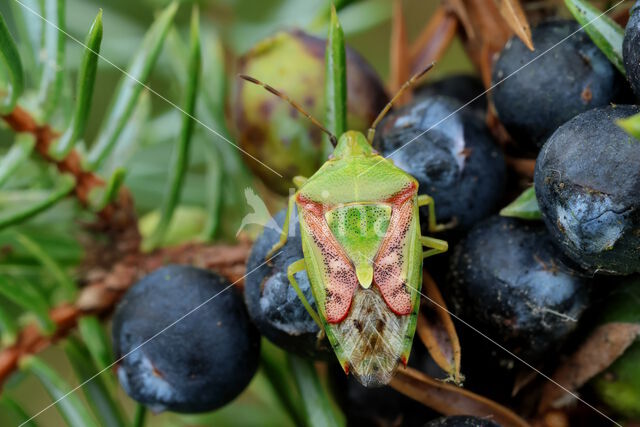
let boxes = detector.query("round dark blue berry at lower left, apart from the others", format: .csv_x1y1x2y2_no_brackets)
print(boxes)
113,265,260,413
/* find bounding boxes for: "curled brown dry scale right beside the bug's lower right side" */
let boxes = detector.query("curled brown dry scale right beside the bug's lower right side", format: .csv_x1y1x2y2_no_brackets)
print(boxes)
417,271,462,384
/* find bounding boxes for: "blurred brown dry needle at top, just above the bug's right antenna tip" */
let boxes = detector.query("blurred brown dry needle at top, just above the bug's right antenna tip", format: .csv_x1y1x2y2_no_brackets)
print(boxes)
409,6,458,74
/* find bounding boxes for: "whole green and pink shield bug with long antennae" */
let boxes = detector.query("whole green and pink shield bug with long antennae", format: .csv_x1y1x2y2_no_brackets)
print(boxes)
240,64,448,386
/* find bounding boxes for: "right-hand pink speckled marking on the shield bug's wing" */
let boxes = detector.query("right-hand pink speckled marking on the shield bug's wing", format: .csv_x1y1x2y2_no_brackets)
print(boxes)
373,183,417,316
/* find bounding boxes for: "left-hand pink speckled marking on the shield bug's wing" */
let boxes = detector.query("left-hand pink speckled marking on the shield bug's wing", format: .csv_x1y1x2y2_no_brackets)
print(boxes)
297,196,358,323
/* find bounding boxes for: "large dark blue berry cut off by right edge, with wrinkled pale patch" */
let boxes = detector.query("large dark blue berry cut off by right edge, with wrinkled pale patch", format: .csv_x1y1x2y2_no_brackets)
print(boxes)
535,105,640,274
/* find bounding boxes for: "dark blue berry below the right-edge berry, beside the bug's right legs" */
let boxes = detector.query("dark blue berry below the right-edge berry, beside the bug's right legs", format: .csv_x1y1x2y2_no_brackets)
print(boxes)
445,216,590,362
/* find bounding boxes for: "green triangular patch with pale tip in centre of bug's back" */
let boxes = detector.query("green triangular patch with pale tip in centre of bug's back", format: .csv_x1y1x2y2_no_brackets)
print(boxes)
325,203,391,288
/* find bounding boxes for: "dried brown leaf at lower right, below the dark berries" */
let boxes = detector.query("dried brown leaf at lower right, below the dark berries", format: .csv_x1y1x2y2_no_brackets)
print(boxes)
538,322,640,414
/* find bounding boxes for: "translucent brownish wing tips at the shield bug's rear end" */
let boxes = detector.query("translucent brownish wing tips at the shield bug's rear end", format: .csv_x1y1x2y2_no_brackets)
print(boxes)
325,287,417,387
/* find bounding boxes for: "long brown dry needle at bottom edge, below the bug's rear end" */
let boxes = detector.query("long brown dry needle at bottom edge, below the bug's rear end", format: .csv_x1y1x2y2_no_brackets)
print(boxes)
390,368,529,427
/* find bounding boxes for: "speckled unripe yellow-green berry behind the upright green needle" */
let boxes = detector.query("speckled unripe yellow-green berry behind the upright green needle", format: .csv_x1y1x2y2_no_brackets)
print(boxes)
232,31,387,194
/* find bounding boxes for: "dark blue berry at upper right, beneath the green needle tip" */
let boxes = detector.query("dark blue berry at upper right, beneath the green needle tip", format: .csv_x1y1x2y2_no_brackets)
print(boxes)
491,21,621,151
